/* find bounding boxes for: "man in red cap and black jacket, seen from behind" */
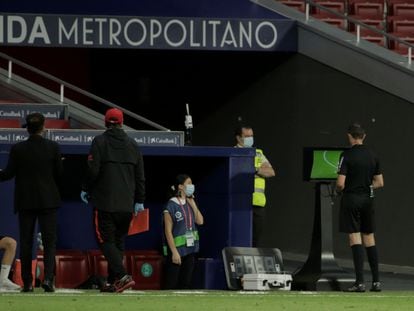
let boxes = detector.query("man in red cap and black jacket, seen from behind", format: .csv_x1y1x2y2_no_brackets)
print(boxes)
81,108,145,292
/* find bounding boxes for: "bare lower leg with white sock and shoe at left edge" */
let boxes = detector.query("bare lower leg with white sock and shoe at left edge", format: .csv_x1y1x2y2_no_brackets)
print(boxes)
0,236,20,290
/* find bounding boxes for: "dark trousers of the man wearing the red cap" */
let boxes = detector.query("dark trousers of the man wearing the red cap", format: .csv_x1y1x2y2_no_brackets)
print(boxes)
94,210,132,284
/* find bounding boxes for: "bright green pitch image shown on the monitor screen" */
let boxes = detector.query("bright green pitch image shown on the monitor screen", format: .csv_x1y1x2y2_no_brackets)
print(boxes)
310,150,342,179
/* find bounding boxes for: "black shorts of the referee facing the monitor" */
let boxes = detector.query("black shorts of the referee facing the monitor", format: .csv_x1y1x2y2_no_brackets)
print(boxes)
339,193,375,234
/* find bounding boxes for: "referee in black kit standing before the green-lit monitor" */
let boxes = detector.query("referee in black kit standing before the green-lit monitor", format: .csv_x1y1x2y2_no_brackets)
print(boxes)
336,123,384,292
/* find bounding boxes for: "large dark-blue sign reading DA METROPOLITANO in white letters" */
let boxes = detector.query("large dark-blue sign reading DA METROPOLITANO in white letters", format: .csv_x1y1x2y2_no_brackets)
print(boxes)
0,13,297,52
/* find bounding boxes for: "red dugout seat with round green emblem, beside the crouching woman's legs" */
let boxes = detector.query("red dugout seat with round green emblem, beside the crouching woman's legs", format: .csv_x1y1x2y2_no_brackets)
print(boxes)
125,250,163,290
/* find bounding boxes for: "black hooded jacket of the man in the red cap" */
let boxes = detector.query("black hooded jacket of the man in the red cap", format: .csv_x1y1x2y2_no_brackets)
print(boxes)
84,128,145,212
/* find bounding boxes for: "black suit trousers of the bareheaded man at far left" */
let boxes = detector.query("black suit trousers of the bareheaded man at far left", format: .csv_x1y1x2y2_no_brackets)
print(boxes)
19,208,57,285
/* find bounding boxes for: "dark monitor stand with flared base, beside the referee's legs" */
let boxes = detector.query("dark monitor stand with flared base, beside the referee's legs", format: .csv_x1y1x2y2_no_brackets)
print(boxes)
292,182,355,291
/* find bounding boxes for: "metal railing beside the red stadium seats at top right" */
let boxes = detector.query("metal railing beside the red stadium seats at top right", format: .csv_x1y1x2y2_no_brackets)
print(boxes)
304,0,414,65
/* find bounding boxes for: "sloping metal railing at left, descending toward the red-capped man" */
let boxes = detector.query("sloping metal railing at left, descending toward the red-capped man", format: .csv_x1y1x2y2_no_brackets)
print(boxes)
0,52,170,131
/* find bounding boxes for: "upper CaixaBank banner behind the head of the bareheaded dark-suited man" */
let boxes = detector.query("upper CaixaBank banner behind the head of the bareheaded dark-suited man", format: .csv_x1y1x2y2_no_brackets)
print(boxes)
0,103,67,120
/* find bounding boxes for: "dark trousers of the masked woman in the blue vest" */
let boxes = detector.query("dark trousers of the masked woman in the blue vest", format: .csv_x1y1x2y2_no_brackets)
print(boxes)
164,254,195,289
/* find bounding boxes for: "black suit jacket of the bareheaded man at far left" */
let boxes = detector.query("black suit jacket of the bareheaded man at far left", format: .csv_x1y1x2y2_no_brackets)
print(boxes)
0,135,63,212
